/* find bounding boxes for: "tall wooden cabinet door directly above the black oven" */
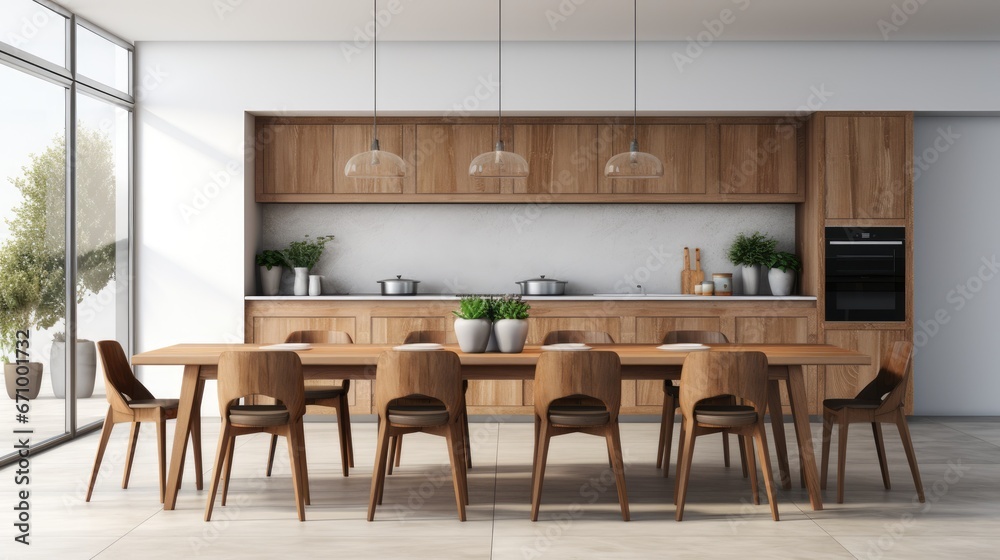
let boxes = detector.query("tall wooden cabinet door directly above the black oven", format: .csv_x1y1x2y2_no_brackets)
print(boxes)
825,116,911,219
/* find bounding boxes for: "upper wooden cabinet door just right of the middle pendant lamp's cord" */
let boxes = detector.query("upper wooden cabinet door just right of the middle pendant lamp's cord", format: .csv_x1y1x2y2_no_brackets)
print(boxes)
508,124,601,195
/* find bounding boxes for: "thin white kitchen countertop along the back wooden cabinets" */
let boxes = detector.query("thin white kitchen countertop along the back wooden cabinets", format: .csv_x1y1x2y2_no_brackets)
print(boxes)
246,294,816,301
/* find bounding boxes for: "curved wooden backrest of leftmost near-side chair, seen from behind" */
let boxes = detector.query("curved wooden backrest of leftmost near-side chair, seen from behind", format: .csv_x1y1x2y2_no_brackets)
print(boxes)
218,351,306,422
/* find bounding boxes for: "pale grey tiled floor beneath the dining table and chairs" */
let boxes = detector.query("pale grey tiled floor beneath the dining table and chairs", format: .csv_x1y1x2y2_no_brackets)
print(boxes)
0,418,1000,560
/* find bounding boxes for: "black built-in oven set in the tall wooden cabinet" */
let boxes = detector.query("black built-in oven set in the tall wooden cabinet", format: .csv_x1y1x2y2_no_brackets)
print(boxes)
826,227,906,322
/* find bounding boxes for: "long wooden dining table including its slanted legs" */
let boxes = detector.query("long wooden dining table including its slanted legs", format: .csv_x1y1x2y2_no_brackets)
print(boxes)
132,344,871,510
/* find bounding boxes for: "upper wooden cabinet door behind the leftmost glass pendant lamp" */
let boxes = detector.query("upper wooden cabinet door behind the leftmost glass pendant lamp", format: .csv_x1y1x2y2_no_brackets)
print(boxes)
333,124,417,194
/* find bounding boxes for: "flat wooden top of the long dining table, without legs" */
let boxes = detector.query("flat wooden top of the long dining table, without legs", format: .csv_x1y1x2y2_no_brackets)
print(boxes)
132,344,871,366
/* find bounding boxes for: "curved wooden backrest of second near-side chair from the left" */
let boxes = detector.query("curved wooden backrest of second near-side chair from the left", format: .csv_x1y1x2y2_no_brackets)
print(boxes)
375,350,463,418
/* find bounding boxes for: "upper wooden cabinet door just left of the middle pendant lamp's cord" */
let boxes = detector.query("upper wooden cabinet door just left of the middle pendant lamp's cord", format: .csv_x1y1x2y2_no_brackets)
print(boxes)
416,124,504,194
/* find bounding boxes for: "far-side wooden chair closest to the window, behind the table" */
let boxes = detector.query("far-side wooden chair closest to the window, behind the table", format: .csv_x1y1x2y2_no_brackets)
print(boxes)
267,331,354,476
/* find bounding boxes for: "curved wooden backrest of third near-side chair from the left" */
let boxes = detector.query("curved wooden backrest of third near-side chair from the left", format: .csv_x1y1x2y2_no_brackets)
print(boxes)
534,350,622,422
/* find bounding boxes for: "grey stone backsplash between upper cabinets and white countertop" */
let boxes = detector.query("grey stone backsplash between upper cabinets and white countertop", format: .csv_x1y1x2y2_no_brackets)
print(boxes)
257,204,795,294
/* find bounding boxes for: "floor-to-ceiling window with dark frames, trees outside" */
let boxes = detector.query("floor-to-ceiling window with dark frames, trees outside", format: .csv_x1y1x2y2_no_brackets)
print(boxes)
0,0,133,463
